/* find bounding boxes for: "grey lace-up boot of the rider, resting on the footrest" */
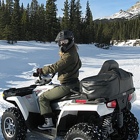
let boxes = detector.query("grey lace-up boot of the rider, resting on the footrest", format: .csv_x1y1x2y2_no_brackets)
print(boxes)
38,118,54,130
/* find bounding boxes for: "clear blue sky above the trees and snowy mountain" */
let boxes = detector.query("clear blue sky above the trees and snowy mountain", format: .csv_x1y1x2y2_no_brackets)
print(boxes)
20,0,139,19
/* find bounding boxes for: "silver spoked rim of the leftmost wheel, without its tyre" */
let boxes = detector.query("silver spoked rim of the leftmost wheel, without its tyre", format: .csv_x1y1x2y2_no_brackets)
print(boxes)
4,117,15,137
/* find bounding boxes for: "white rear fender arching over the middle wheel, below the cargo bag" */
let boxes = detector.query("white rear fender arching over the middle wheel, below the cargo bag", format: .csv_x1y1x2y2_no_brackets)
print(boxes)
57,103,114,126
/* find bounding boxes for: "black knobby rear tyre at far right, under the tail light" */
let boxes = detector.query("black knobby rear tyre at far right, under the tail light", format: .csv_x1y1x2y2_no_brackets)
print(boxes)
111,111,139,140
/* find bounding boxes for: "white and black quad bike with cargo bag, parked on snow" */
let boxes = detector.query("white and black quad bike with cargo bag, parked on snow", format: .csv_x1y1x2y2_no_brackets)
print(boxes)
1,60,139,140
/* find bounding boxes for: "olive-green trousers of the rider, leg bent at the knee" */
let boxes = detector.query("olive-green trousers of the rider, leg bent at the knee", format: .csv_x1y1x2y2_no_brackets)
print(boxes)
39,81,79,115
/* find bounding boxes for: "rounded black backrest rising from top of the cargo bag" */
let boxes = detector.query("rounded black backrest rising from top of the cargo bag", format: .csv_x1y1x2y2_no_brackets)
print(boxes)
98,60,119,74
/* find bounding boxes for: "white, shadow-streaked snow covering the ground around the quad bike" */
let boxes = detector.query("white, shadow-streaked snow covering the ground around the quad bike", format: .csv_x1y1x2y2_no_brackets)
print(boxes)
0,40,140,140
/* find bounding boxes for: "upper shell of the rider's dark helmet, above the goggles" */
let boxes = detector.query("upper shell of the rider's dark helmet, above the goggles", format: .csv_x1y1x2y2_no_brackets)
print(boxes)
55,30,74,42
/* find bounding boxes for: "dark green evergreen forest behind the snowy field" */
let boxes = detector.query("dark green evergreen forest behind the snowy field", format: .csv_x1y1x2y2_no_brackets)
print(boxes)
0,0,140,44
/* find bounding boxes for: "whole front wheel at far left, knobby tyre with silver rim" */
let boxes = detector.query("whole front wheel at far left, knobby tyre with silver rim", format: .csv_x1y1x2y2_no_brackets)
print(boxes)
1,107,27,140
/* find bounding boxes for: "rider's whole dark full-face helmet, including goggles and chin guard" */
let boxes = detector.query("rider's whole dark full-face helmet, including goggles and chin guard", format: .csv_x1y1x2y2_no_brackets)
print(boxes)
55,30,74,52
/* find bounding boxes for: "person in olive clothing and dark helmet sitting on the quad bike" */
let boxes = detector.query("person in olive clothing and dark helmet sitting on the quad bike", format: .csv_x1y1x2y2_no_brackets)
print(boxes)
37,30,81,130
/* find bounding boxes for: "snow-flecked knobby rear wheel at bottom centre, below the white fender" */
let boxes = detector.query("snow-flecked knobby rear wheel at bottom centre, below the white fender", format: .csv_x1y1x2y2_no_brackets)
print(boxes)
64,123,103,140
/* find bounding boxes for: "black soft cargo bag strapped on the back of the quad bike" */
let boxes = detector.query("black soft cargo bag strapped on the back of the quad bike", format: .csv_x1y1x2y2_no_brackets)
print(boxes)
80,68,134,100
